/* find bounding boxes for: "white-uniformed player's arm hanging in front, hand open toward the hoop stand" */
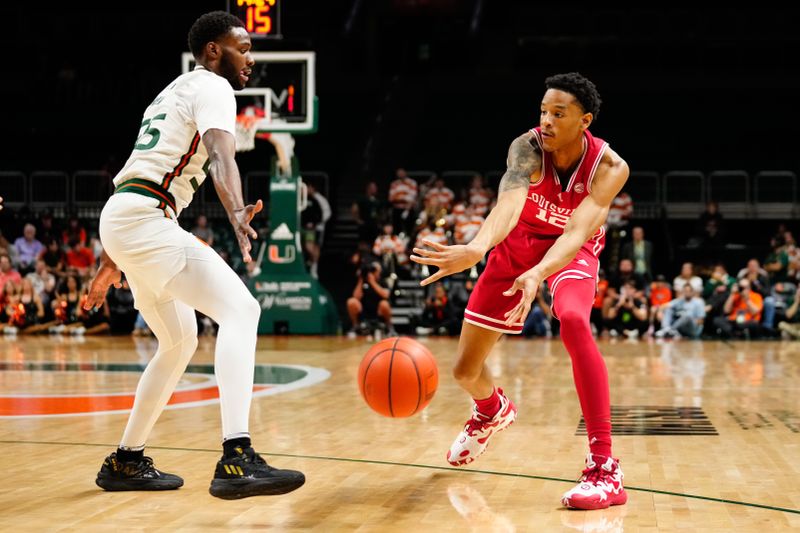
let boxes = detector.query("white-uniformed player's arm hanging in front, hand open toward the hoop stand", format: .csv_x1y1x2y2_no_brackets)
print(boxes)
203,128,264,263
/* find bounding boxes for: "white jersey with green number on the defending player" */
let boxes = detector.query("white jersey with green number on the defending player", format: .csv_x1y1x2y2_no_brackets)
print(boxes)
114,67,236,215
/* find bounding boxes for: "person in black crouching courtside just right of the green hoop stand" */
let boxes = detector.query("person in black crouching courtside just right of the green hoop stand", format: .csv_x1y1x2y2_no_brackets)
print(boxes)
347,261,397,338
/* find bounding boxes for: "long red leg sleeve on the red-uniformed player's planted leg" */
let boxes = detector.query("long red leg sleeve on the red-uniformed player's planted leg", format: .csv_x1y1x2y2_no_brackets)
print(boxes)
553,279,611,457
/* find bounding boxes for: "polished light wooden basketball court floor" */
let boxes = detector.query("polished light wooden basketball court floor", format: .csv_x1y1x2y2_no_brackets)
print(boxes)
0,337,800,532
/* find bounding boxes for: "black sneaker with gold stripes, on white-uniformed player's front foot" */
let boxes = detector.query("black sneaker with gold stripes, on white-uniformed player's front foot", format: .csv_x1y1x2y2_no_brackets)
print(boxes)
208,447,306,500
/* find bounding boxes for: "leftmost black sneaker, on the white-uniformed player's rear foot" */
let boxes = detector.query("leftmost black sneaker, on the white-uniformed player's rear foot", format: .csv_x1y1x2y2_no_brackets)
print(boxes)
95,452,183,491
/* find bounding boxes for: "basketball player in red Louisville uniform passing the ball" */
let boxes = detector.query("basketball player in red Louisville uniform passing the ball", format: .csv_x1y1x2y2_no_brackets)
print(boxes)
411,72,628,509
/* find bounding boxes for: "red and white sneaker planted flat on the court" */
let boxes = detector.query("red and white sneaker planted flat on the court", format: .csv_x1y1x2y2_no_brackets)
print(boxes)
561,453,628,510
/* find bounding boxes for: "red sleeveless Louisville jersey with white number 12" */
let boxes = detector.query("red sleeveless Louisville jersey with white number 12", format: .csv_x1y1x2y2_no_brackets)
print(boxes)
517,128,608,257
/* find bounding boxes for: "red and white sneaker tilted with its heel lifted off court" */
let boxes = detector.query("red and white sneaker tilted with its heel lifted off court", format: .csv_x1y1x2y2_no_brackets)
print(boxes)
447,388,517,466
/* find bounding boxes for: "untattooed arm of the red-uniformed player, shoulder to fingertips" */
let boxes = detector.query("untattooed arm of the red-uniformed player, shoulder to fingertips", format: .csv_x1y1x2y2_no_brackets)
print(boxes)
503,148,629,325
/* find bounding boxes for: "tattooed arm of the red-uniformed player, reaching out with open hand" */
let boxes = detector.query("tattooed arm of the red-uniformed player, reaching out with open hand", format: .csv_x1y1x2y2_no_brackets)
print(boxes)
411,132,542,285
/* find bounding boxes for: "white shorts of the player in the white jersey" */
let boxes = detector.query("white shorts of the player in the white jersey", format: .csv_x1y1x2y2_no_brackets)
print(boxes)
100,192,208,309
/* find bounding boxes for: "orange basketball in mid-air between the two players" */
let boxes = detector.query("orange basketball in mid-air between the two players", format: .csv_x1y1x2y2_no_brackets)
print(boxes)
358,337,439,418
